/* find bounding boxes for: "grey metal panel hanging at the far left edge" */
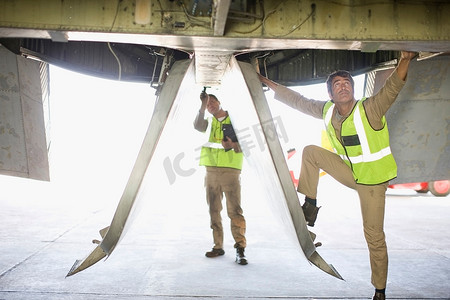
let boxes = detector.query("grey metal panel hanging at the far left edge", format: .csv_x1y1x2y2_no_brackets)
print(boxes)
0,45,50,181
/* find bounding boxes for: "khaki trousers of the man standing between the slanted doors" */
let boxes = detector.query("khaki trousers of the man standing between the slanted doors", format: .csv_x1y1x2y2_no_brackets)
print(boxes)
205,167,247,249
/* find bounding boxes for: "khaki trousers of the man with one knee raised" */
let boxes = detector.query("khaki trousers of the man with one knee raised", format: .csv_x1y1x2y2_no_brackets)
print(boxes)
298,145,388,289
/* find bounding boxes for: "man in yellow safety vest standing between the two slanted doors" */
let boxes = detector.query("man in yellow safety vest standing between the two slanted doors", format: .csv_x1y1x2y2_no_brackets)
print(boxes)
194,92,247,265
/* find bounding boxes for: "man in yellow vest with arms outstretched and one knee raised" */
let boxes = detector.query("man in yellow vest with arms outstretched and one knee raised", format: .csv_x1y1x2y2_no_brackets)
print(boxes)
259,51,415,300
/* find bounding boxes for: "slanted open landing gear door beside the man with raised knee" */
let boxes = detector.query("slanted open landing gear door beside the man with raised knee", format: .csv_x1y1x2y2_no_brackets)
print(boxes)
217,58,342,279
